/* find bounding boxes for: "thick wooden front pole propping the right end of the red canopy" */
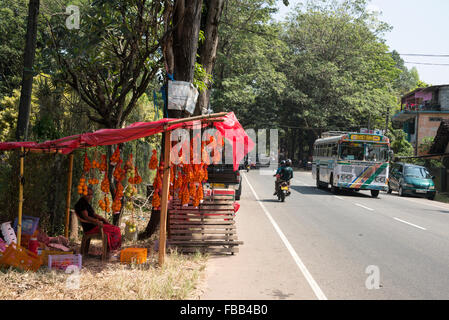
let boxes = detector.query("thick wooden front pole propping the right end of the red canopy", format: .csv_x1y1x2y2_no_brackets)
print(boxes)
159,131,171,267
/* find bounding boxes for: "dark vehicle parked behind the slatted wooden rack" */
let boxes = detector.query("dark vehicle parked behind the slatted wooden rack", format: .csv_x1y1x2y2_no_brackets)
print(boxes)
207,164,242,200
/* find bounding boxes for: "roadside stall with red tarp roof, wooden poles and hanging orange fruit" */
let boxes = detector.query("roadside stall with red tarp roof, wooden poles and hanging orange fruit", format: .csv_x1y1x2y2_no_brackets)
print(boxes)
0,112,254,265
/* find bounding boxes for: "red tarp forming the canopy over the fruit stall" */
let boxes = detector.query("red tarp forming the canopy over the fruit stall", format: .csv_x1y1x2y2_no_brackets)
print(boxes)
0,112,255,170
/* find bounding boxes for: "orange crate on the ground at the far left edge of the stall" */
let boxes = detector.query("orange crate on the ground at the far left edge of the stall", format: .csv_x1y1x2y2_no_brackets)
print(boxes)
0,244,42,271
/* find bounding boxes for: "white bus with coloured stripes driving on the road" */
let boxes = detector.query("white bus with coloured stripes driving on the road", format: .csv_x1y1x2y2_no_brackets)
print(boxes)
312,132,392,198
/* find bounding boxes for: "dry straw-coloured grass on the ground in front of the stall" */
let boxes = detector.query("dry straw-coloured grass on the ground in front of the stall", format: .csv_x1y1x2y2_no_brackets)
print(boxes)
0,205,207,300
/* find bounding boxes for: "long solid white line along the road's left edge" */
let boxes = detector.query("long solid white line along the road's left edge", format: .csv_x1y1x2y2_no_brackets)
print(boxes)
243,175,327,300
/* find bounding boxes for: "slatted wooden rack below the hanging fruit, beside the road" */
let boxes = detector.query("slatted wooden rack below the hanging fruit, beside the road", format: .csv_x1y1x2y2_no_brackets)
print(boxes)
168,198,243,254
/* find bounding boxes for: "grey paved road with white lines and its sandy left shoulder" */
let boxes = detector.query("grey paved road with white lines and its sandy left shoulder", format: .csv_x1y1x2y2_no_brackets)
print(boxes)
202,170,449,300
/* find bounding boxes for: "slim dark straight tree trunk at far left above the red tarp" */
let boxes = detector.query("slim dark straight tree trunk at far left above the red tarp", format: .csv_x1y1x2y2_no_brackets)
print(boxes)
16,0,39,141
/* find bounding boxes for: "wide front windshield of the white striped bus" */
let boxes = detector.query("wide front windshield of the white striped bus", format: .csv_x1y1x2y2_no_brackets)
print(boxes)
340,142,388,162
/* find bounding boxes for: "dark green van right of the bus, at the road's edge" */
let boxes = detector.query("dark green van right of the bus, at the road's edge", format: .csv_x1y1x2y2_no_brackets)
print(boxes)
388,162,436,200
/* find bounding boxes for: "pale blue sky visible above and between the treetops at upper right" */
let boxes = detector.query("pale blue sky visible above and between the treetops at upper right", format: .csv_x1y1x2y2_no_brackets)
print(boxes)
277,0,449,85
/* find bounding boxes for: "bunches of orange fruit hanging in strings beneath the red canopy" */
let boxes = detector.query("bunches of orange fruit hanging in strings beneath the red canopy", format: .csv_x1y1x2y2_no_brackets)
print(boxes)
78,127,222,220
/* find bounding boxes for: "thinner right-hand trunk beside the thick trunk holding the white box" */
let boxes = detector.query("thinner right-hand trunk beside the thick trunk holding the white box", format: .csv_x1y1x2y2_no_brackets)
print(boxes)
195,0,225,115
